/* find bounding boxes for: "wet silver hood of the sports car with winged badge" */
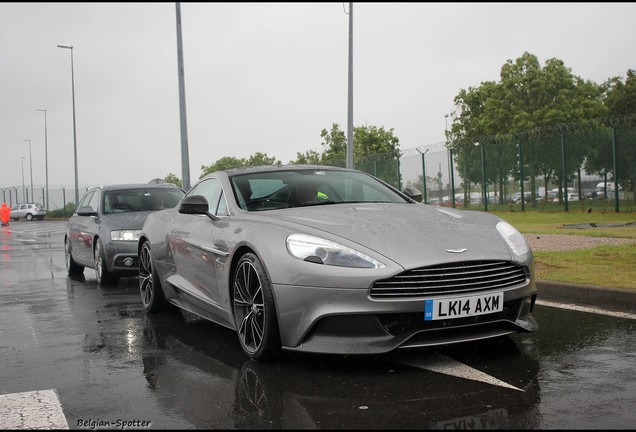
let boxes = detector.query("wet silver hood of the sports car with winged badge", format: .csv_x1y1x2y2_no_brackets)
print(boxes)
259,203,512,268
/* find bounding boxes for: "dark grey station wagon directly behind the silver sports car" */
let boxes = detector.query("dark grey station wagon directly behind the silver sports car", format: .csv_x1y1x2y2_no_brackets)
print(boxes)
64,183,185,284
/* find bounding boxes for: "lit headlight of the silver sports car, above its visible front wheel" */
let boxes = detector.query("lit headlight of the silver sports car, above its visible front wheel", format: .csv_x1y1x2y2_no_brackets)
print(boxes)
287,234,386,268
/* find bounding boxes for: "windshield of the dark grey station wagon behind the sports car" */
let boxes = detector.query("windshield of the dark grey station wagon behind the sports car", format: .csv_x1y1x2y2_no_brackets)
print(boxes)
102,188,184,214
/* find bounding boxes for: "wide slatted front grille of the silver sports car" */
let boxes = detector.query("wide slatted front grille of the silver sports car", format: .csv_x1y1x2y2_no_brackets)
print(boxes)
370,261,529,298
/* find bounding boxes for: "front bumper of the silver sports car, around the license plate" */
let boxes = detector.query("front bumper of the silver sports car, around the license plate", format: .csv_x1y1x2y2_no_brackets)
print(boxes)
273,283,538,354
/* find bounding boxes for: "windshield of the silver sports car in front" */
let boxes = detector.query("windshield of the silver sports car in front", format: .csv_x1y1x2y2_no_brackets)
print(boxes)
231,169,409,211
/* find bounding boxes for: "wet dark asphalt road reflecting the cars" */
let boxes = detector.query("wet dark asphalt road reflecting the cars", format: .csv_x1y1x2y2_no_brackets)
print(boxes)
0,220,636,429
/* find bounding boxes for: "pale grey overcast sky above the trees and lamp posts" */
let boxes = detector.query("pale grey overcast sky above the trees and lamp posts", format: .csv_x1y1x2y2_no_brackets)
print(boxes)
0,3,636,188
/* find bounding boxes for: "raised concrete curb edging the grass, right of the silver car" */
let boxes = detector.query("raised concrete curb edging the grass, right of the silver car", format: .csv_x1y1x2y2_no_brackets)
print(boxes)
535,280,636,313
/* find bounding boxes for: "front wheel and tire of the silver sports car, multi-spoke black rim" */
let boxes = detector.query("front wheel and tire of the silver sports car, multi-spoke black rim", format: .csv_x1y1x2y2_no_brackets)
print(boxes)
232,253,281,361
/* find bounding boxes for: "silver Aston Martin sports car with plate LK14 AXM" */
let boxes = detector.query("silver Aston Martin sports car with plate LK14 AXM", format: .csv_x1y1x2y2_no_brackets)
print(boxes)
138,165,538,360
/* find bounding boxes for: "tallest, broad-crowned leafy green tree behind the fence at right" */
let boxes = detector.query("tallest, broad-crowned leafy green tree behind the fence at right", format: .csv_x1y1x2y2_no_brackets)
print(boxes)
451,52,606,205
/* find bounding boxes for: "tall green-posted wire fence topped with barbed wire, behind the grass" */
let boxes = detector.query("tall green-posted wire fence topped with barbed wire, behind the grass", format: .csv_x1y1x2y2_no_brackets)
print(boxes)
327,116,636,212
